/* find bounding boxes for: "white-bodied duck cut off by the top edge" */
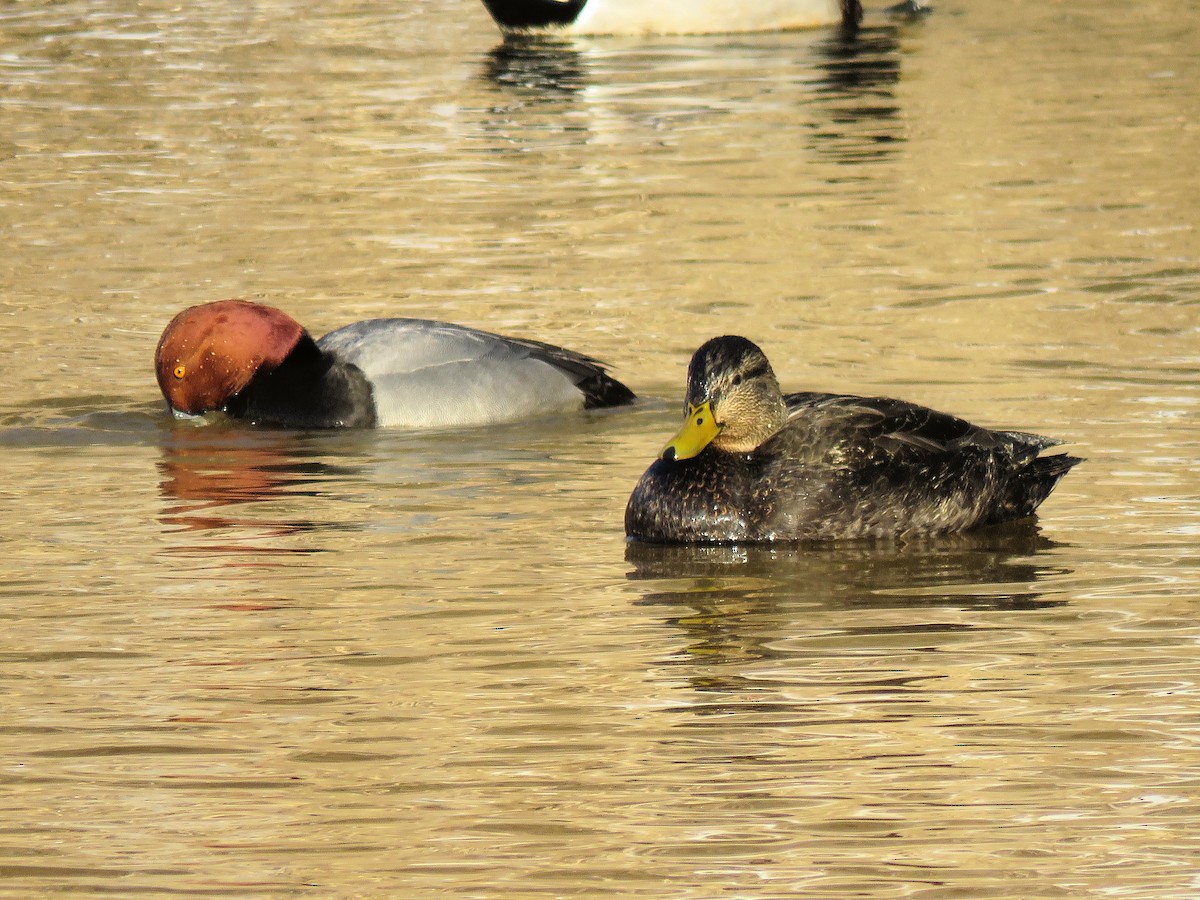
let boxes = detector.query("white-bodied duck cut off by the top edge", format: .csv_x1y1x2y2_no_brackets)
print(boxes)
484,0,863,36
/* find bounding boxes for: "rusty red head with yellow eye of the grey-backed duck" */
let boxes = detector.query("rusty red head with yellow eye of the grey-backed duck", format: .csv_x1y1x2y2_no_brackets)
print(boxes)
155,300,305,415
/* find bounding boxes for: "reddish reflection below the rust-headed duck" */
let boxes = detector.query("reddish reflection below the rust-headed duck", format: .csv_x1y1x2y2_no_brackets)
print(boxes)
158,426,353,552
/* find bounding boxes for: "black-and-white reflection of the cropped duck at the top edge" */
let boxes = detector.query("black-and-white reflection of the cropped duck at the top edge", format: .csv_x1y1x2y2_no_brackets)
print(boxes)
481,24,905,163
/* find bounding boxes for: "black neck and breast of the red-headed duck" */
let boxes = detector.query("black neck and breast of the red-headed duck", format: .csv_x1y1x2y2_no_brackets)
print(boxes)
226,334,376,428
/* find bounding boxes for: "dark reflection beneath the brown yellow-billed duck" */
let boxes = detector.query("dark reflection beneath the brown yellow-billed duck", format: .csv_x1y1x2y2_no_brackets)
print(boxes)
626,522,1066,678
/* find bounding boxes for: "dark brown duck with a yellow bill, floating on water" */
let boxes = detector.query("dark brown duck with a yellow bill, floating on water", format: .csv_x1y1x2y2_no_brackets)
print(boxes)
625,335,1082,544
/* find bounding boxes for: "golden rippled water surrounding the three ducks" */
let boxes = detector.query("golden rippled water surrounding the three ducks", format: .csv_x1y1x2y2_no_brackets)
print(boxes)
0,0,1200,898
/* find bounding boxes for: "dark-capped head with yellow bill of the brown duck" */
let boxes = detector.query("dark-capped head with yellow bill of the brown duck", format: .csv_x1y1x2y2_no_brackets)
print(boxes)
660,335,787,460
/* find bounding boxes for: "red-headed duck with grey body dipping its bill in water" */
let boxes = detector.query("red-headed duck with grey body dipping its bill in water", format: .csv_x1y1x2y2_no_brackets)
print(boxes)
155,299,635,428
